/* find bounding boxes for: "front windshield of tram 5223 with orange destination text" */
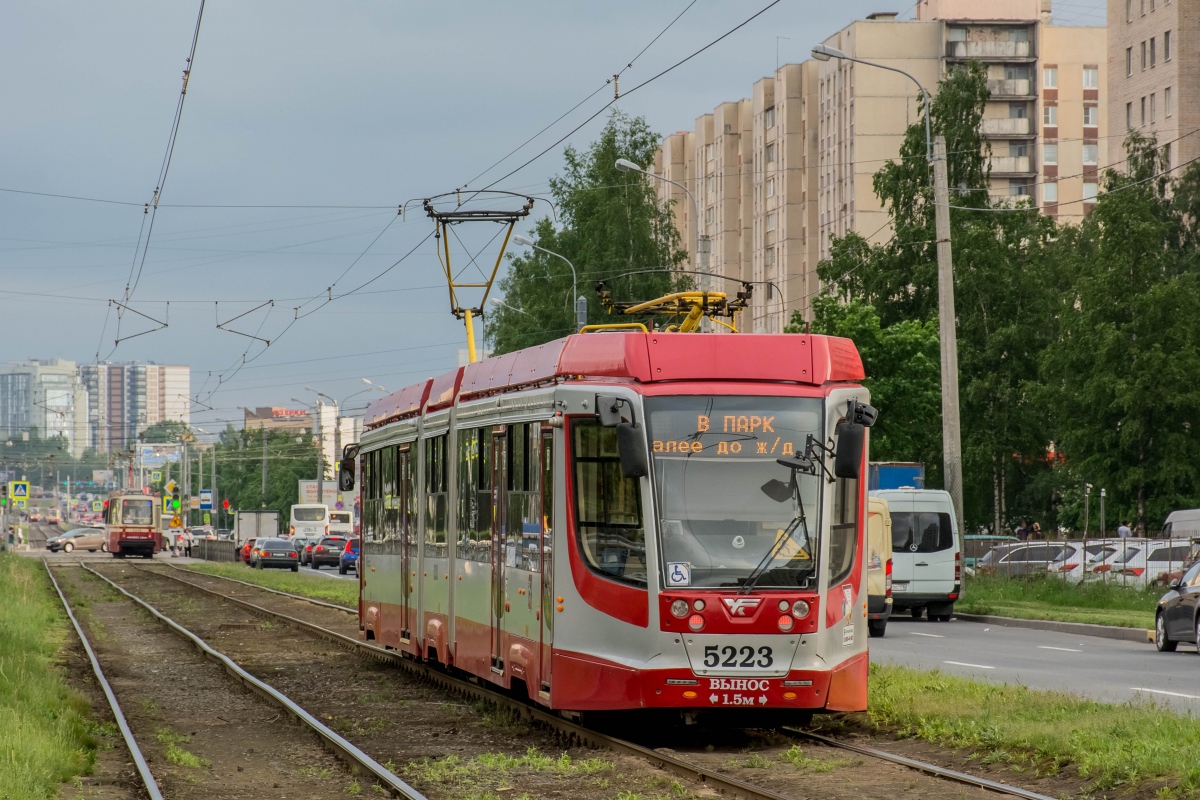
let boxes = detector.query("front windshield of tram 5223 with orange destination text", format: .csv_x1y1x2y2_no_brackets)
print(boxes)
646,396,823,589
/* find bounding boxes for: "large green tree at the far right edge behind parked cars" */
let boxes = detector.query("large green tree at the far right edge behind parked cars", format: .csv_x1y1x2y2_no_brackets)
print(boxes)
1044,133,1200,531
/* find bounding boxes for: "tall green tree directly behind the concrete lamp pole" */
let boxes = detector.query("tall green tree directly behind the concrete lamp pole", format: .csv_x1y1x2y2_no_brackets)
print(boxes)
817,62,1055,529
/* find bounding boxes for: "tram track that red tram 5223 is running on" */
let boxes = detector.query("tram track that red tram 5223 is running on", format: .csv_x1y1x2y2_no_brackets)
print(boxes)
105,565,1052,800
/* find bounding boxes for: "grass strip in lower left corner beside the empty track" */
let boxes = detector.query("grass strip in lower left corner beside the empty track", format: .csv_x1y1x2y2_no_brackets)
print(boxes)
0,553,96,800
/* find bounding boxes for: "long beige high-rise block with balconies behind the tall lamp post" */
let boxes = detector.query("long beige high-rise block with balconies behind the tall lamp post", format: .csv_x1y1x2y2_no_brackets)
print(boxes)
654,0,1104,331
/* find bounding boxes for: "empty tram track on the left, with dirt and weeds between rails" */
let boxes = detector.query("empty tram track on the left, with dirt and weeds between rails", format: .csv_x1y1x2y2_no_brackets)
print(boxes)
43,560,426,800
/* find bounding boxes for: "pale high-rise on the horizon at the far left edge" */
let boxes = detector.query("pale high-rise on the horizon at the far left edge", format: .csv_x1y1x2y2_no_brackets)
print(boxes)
0,359,88,458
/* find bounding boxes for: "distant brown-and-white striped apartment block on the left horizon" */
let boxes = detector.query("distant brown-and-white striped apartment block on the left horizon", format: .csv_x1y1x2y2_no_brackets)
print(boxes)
79,362,192,452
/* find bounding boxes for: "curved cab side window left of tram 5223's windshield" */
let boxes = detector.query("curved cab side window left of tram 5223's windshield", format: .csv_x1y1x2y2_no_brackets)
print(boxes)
571,420,646,587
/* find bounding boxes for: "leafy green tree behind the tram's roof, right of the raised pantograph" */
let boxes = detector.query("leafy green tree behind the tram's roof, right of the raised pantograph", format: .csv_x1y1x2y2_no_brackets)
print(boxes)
486,112,688,354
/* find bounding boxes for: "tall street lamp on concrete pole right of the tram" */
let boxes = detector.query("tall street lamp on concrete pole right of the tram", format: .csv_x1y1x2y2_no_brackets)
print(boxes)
812,37,965,547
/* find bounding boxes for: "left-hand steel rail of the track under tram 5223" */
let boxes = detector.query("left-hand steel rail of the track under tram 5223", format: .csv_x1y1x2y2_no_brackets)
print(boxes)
117,565,793,800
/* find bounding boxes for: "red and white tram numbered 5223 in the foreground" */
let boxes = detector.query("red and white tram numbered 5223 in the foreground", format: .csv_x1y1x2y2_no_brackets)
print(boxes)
341,332,875,717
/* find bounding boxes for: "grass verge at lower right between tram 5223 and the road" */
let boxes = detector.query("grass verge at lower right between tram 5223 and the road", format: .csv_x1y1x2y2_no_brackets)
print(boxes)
866,663,1200,798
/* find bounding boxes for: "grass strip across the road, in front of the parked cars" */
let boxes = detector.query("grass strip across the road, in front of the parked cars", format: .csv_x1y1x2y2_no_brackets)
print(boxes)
954,576,1164,628
